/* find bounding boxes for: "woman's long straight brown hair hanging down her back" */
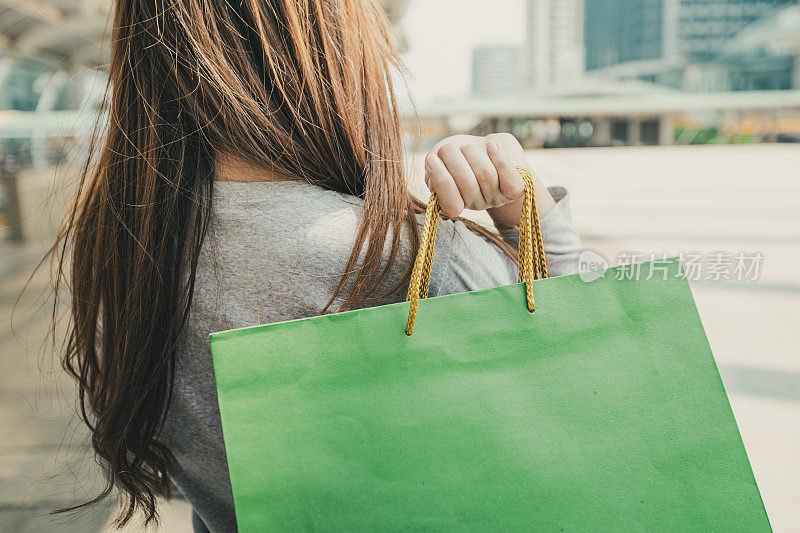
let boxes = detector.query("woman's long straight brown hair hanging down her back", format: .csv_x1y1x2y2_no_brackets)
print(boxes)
51,0,508,525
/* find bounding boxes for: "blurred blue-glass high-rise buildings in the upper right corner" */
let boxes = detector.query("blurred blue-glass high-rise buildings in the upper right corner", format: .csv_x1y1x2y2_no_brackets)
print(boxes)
584,0,800,91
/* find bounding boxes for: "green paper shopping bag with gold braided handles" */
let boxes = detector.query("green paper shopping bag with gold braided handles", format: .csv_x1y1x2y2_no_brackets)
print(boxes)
211,169,770,532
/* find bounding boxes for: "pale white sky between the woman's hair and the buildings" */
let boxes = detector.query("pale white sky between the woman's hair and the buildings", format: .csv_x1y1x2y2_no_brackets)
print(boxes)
401,0,525,104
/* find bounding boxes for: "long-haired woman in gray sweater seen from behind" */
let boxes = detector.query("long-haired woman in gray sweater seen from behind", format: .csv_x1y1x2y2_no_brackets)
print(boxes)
54,0,580,531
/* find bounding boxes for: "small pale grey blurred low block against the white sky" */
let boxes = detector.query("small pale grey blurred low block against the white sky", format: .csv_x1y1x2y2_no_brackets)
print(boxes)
472,46,522,96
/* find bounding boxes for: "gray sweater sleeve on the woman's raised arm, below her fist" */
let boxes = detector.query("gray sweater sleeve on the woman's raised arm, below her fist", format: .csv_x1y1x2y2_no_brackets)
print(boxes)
429,187,583,296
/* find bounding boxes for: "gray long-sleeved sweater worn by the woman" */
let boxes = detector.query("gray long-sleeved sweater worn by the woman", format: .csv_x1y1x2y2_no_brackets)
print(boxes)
162,182,582,532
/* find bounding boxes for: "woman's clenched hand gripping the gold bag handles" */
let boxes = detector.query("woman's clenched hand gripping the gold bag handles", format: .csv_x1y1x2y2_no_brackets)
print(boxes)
425,133,555,226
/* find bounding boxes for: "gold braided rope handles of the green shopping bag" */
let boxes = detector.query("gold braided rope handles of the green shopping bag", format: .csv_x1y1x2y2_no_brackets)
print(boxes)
406,166,547,335
